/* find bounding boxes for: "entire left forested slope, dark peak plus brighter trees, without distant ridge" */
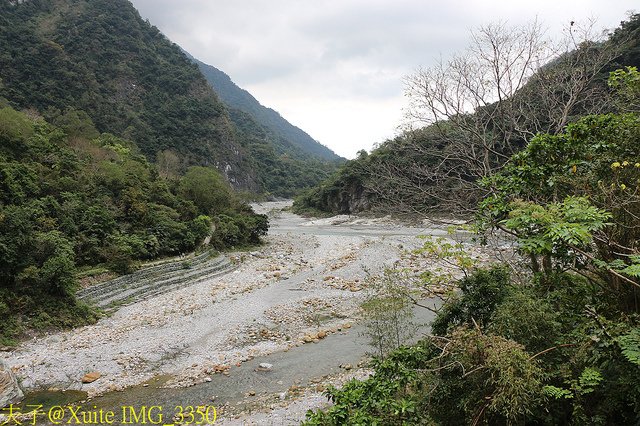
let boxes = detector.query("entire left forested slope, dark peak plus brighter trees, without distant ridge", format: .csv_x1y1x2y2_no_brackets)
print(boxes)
0,0,278,345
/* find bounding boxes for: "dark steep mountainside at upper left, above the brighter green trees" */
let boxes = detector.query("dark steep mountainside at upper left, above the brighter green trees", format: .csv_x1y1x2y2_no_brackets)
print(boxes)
0,0,258,190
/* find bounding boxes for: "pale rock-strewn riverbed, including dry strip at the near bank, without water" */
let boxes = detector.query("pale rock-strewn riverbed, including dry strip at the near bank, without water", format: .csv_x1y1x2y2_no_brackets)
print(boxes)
3,203,500,424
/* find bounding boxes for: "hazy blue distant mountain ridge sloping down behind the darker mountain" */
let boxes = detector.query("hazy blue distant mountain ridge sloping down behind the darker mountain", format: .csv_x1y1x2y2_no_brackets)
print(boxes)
189,55,341,160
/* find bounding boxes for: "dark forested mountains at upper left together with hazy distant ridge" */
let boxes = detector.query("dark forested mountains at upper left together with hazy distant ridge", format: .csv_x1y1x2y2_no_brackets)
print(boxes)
0,0,339,196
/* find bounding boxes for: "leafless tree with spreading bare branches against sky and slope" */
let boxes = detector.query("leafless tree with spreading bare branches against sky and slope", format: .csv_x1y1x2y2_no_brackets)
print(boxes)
368,21,622,214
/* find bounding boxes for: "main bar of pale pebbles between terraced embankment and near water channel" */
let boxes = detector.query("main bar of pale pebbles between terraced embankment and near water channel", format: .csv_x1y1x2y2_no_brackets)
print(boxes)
3,205,490,418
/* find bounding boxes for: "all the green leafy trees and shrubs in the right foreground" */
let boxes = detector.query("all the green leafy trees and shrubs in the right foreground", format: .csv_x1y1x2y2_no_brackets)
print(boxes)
306,33,640,425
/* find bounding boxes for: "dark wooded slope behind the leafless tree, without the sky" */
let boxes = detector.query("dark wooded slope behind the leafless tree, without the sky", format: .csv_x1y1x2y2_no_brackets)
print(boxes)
294,14,640,215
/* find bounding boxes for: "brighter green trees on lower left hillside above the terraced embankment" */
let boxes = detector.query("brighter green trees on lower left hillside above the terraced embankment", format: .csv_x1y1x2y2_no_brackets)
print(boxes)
0,105,267,344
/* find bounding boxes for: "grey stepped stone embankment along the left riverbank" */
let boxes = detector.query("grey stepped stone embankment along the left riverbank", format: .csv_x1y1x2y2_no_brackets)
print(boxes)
77,251,234,308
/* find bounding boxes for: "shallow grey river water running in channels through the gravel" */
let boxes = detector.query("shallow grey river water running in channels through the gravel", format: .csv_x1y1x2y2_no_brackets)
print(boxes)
18,205,446,424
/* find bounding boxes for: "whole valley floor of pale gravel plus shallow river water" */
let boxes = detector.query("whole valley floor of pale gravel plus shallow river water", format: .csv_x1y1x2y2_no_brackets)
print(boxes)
7,202,484,421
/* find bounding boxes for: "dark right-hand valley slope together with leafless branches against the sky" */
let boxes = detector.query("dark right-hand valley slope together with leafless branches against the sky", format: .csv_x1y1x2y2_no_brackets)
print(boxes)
295,15,640,215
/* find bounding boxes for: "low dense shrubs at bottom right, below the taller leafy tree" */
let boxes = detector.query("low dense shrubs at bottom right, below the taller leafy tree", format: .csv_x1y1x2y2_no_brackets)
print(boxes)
307,268,640,425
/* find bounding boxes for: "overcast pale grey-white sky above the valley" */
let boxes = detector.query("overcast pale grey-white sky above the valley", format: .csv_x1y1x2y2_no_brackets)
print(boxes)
132,0,638,158
